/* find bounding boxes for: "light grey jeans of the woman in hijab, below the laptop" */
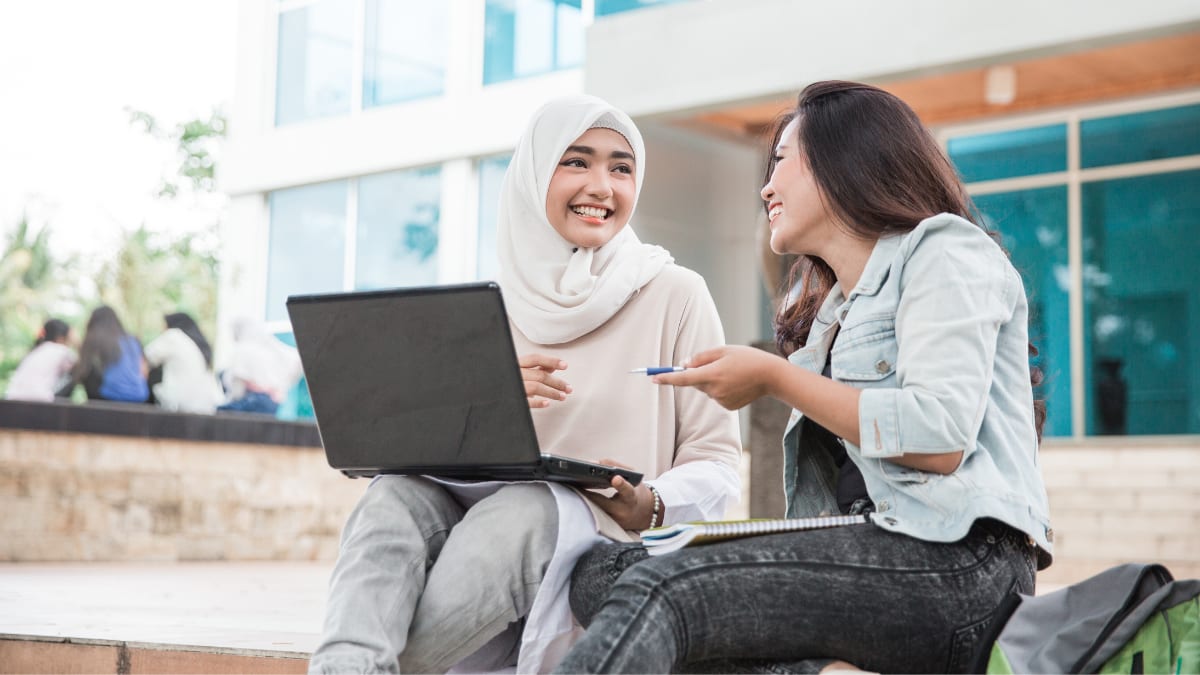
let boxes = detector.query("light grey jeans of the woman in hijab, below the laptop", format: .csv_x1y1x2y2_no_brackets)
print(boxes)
308,476,558,673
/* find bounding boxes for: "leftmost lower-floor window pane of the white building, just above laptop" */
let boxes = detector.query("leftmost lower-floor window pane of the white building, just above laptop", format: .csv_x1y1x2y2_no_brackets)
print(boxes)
266,180,347,321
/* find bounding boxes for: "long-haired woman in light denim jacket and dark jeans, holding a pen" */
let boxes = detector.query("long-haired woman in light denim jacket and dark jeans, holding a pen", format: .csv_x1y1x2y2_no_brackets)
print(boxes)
559,82,1052,673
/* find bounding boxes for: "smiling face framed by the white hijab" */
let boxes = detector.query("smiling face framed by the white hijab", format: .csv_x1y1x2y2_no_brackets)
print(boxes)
546,127,637,249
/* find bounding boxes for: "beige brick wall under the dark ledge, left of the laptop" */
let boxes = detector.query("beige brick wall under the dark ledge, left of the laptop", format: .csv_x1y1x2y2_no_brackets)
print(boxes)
0,429,367,561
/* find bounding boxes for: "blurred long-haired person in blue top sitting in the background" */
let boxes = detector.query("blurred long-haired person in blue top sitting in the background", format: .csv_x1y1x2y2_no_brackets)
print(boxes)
59,305,150,404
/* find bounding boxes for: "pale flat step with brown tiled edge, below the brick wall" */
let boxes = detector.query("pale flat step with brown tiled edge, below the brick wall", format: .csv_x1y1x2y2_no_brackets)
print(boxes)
0,562,332,674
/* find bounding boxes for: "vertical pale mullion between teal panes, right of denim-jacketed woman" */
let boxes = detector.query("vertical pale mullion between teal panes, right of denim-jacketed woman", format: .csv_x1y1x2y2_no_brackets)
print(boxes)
1067,114,1087,438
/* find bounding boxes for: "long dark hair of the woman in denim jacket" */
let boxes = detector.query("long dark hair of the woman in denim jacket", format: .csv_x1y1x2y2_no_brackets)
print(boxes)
763,80,1046,440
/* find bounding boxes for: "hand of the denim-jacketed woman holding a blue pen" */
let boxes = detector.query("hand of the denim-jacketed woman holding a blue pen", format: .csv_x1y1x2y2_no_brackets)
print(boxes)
654,346,787,410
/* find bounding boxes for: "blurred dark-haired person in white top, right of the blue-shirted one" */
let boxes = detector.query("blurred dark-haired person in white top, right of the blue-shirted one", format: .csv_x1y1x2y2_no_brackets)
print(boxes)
145,312,224,414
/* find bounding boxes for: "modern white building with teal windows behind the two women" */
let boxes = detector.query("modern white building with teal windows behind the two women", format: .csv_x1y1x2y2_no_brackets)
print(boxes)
221,0,1200,446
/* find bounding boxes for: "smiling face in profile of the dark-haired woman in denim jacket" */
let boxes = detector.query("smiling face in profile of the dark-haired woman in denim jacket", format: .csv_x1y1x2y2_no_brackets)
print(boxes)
762,119,835,256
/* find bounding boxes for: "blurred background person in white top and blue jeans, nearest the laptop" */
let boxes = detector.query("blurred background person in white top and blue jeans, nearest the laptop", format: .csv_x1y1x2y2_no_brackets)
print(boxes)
217,317,301,414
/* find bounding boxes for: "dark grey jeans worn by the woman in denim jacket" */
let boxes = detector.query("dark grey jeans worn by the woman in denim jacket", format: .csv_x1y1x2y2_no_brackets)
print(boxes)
557,520,1034,673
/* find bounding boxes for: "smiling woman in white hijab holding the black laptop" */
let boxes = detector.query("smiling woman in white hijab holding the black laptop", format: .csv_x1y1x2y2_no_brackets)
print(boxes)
310,96,740,673
